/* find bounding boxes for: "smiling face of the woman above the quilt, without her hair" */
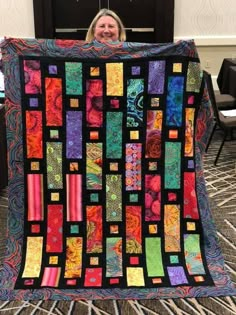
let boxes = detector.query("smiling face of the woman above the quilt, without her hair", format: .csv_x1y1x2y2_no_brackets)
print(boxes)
94,15,119,42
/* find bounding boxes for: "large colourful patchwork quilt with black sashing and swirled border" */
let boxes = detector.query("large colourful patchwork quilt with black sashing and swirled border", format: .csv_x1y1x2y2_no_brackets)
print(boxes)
0,39,236,300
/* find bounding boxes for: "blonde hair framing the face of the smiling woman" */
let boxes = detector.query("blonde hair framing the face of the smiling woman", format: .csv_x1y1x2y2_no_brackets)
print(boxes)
85,9,126,42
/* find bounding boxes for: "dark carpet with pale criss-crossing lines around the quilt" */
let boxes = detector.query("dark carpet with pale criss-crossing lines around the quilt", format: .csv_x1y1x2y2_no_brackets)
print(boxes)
0,133,236,315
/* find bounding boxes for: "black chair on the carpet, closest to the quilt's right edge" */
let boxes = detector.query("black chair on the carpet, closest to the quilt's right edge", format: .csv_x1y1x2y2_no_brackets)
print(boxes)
203,70,236,165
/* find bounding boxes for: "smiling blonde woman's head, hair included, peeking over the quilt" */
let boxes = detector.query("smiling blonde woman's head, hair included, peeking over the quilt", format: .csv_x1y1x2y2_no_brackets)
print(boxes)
85,9,126,42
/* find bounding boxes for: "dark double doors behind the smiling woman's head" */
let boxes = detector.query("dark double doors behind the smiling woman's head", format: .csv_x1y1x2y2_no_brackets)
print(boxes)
33,0,174,43
